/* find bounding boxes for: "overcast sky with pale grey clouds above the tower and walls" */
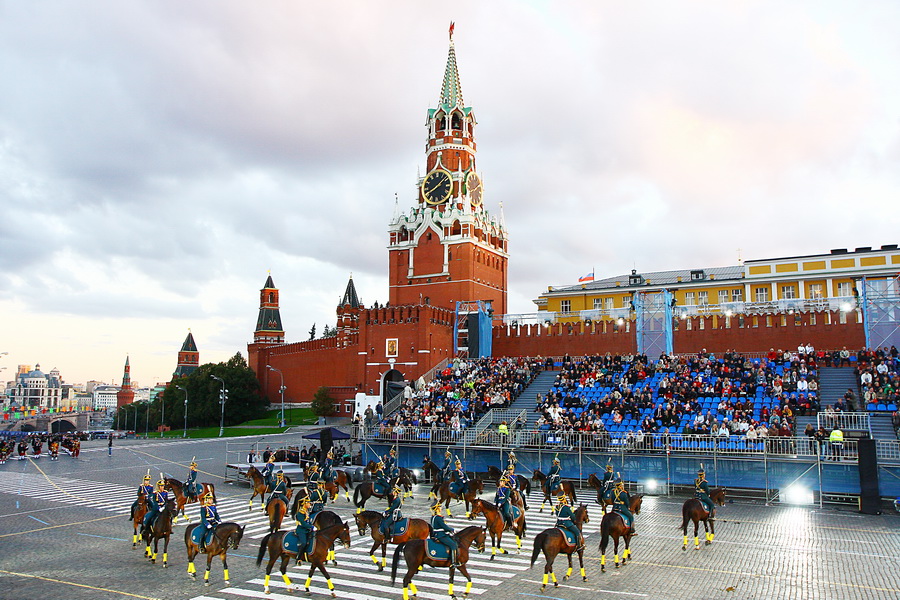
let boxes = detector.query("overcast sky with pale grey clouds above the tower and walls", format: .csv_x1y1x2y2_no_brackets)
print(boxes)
0,0,900,384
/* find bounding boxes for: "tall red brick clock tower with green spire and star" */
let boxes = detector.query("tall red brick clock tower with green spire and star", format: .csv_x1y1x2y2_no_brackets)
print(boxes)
388,25,509,315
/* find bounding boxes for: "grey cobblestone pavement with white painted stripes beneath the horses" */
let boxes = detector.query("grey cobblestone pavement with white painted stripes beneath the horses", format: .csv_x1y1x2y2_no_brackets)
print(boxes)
0,436,900,600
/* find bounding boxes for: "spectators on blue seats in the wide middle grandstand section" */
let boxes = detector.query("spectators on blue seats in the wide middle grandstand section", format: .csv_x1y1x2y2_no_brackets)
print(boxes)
537,345,819,444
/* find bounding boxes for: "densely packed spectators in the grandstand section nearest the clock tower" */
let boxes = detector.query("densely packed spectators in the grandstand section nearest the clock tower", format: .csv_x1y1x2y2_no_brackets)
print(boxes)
354,357,545,434
